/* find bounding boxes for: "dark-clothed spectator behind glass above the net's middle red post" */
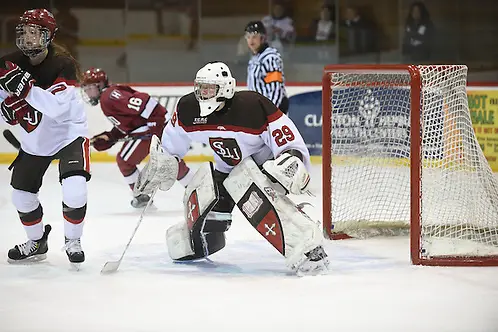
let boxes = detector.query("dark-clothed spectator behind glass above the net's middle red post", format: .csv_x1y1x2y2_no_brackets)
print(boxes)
402,2,434,62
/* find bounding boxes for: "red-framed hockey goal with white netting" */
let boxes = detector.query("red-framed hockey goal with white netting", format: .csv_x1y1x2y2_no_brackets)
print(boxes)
323,65,498,265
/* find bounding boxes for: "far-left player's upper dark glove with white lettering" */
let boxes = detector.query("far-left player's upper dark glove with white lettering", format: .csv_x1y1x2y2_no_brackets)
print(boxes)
0,61,35,99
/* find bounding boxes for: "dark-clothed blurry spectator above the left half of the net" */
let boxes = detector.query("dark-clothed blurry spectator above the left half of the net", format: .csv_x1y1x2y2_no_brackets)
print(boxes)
344,7,377,54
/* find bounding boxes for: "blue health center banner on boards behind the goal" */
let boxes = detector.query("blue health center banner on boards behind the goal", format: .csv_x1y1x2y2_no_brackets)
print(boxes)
289,87,410,157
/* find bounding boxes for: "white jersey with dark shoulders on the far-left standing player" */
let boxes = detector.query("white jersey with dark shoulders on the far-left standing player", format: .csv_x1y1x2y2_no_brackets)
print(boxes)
0,46,88,156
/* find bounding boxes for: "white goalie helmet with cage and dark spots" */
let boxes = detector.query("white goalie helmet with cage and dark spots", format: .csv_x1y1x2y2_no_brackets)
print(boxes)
194,62,235,116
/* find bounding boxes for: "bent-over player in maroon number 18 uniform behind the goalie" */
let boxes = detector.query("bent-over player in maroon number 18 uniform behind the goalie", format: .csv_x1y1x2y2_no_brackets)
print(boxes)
81,68,189,208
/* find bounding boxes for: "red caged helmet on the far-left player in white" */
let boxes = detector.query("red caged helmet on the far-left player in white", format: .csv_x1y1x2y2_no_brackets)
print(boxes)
16,9,57,58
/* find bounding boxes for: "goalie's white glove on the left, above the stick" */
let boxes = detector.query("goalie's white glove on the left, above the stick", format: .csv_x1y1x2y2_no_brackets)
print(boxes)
133,135,179,196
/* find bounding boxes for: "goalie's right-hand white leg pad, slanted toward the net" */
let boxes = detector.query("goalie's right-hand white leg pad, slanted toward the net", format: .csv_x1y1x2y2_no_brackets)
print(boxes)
223,158,326,270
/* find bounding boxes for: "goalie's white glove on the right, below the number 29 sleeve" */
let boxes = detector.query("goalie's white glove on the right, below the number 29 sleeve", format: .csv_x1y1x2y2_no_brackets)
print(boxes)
263,150,310,195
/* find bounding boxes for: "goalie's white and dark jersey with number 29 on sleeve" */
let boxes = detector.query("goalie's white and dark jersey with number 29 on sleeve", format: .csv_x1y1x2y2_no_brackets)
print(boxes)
162,91,311,173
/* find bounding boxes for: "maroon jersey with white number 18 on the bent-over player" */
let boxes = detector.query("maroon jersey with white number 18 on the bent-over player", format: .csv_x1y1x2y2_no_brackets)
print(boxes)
100,85,167,139
